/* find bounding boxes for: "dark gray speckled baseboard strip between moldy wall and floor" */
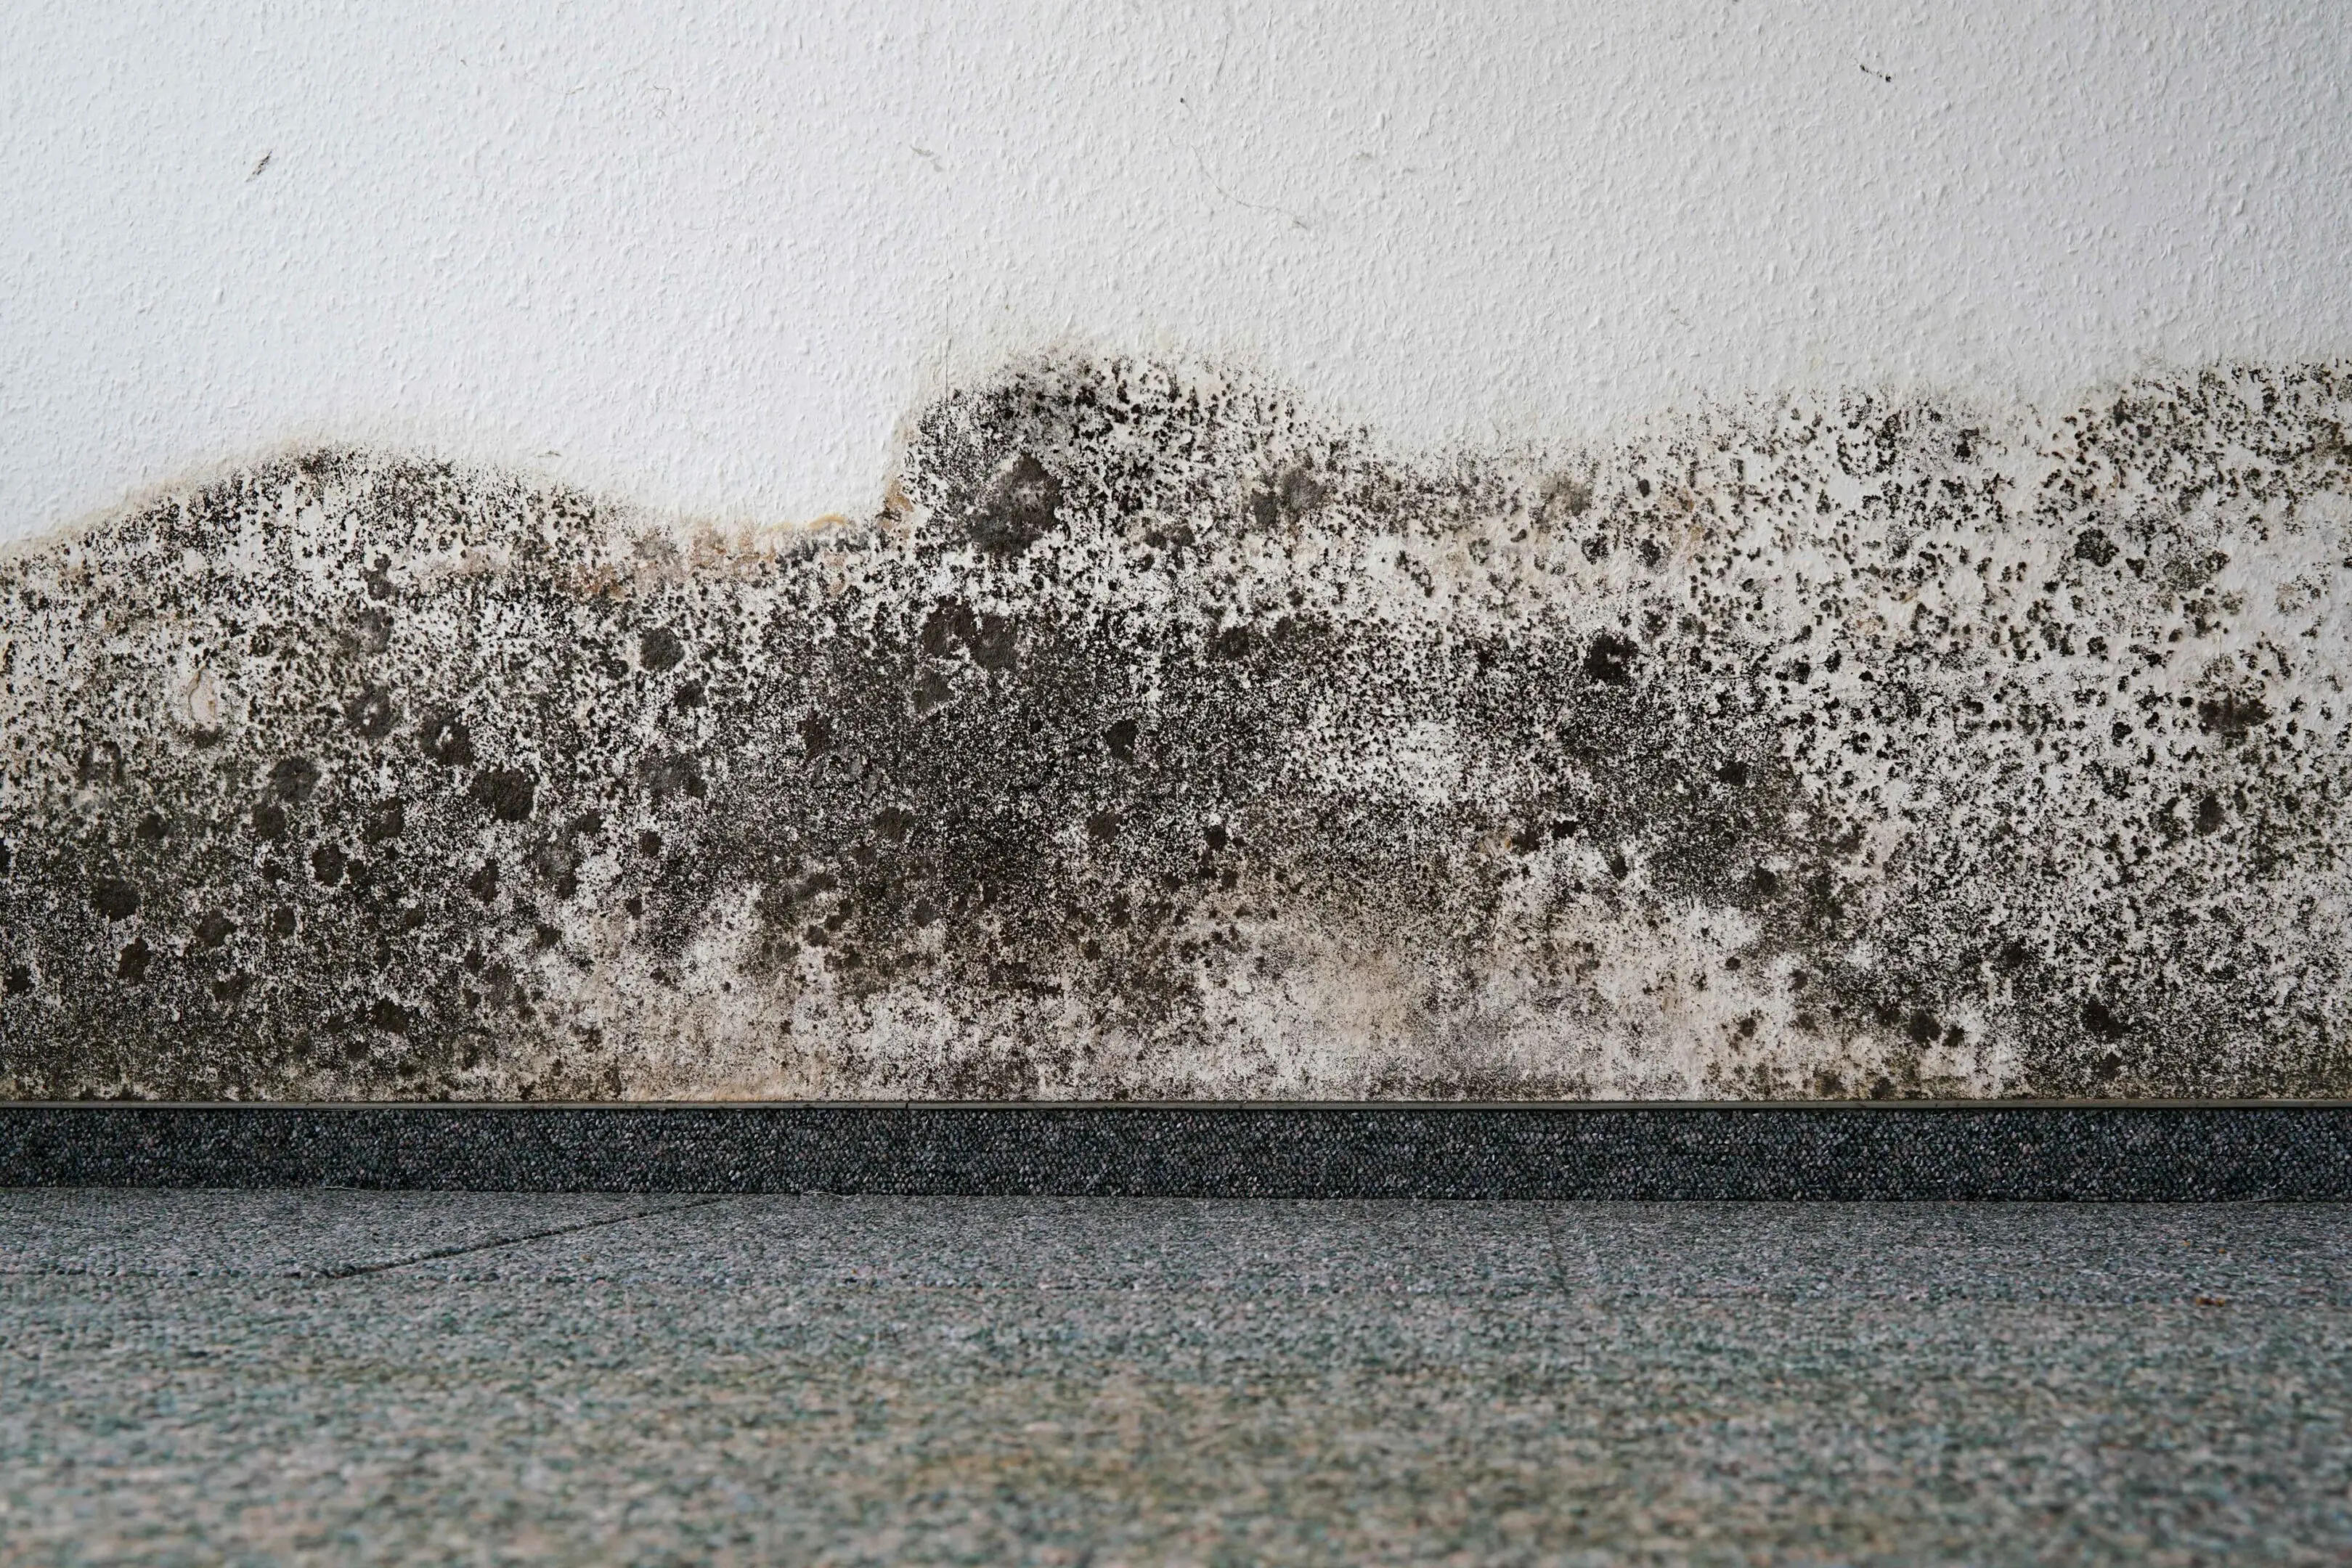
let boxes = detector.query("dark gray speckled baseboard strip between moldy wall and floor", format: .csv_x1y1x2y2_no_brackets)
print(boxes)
0,1105,2352,1201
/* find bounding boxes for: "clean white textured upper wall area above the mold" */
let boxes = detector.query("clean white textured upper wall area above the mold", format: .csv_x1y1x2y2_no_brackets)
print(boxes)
0,0,2352,536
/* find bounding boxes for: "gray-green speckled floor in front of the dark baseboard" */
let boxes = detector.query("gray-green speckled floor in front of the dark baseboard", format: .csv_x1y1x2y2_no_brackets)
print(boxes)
0,1192,2352,1568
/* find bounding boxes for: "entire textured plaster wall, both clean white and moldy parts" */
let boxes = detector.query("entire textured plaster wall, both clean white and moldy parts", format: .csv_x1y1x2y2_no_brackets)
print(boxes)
0,4,2352,1098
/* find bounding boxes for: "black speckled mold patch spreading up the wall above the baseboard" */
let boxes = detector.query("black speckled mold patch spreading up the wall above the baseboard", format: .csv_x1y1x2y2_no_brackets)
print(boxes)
0,357,2352,1101
